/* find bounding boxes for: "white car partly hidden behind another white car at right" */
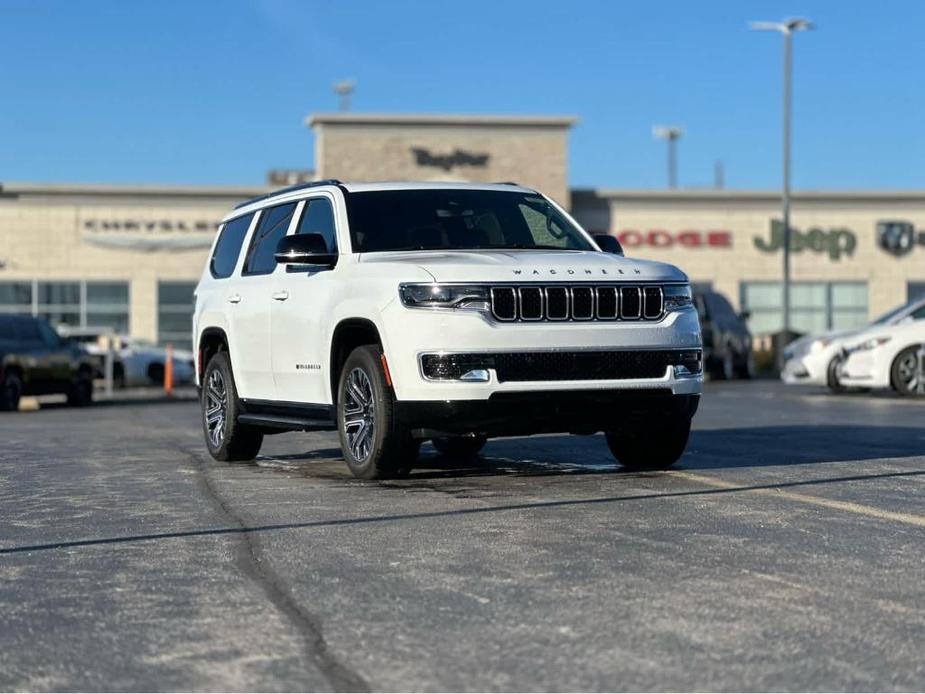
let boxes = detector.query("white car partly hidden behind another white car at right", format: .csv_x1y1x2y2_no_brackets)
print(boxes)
781,298,925,392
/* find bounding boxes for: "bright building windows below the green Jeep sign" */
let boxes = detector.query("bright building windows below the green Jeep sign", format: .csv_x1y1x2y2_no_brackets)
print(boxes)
740,282,869,335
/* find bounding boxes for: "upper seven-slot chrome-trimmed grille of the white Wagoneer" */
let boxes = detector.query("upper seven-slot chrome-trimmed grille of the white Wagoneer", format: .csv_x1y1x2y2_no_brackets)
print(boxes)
491,285,665,323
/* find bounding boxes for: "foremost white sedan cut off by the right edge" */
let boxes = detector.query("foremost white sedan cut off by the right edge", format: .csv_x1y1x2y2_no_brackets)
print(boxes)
838,320,925,395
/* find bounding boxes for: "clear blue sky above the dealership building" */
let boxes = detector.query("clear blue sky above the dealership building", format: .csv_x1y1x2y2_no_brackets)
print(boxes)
0,0,925,189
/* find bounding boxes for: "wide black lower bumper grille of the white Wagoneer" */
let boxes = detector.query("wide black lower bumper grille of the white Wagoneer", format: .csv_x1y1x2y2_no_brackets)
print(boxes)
421,349,703,383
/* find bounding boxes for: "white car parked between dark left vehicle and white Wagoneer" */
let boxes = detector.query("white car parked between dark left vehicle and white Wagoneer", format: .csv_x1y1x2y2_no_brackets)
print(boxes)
61,328,195,387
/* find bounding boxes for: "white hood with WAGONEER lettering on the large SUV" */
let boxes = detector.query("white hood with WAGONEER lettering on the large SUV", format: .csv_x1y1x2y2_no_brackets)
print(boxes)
360,250,687,283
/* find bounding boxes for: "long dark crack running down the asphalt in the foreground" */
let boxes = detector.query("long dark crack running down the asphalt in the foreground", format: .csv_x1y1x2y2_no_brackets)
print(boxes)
177,446,370,692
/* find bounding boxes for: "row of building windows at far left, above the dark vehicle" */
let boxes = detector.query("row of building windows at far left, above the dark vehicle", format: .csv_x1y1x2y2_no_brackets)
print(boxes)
0,280,129,333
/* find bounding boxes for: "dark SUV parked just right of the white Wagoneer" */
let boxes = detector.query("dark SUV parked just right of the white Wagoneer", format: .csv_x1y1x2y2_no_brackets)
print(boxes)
694,291,755,380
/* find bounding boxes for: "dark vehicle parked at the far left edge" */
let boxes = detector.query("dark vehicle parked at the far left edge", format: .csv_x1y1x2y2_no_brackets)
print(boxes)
0,315,93,410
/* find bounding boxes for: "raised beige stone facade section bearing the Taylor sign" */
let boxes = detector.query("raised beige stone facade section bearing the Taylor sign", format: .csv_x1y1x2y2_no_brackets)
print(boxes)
307,113,576,207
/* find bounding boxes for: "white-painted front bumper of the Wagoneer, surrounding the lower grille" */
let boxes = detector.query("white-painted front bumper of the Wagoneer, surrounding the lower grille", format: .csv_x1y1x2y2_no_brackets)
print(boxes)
382,302,703,402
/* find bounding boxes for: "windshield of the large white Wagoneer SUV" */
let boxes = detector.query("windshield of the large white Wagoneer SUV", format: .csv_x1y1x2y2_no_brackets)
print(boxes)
347,189,596,253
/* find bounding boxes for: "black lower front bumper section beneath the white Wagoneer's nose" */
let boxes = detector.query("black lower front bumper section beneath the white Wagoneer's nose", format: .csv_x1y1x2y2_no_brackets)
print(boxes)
395,388,700,438
